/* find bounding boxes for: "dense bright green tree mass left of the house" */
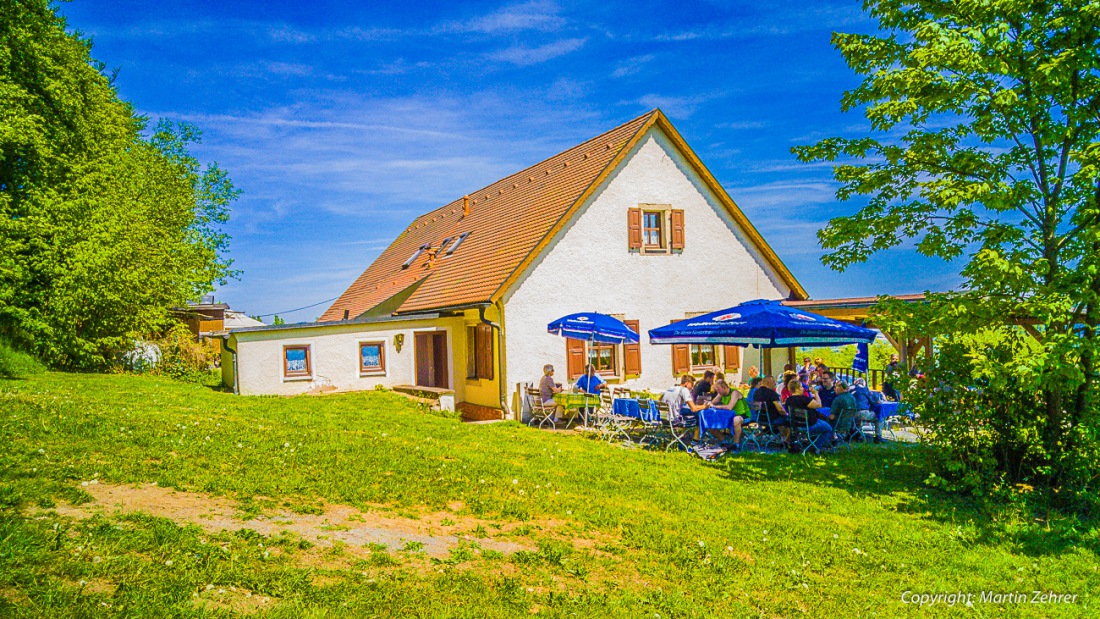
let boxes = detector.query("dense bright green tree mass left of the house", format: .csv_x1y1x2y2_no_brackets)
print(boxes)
0,0,238,367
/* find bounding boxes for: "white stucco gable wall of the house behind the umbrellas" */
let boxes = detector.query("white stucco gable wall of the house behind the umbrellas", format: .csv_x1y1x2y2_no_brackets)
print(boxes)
505,128,790,398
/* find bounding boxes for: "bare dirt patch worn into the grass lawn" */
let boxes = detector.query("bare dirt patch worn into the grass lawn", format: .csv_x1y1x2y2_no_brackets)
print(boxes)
56,484,535,557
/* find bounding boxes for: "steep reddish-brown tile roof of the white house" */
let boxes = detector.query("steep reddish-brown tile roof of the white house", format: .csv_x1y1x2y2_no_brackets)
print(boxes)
320,110,805,321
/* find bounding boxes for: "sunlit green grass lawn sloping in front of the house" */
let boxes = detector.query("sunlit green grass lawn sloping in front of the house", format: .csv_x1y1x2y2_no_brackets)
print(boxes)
0,373,1100,618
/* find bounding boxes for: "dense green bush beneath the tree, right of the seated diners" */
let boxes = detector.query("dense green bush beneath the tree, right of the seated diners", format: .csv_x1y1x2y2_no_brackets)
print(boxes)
902,328,1100,512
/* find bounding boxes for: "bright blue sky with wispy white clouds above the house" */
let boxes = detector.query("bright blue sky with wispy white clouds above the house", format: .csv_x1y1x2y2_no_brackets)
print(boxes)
62,0,959,321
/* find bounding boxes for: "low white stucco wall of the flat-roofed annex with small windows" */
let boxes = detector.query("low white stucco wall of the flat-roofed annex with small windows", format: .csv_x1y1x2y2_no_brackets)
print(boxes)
235,318,465,401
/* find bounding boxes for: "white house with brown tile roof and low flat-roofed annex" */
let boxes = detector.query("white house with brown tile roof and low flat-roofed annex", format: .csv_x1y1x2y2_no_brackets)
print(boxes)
222,110,806,422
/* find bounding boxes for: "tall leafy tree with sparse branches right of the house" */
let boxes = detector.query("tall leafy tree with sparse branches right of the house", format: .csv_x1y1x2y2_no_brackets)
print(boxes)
794,0,1100,503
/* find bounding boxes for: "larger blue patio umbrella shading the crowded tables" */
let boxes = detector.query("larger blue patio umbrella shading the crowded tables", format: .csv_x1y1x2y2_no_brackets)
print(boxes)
649,299,878,349
